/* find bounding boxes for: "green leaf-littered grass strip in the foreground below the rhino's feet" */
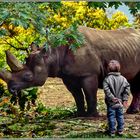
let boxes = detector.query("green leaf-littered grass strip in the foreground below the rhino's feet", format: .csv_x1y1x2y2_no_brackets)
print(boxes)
0,105,140,138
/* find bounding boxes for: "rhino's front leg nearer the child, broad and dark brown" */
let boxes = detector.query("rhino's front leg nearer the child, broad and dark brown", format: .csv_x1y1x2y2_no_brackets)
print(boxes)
82,75,99,116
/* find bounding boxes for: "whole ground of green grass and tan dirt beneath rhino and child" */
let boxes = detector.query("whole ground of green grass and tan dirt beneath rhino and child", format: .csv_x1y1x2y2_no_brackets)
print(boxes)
0,78,140,140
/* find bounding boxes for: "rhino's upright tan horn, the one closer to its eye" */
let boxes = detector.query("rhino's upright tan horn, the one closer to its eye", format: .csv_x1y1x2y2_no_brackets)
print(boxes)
5,50,23,72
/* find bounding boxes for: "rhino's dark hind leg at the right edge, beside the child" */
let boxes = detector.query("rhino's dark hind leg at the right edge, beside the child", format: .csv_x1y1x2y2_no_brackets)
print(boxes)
127,73,140,114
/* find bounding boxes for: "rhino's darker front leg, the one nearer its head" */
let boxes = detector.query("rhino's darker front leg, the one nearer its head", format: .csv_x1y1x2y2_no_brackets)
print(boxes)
63,77,86,117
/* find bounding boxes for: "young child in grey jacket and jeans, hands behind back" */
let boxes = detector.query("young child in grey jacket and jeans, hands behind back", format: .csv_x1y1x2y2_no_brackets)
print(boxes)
103,60,130,136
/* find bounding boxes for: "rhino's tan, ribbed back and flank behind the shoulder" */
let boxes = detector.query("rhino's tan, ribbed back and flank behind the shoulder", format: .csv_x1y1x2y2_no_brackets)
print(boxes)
79,26,140,79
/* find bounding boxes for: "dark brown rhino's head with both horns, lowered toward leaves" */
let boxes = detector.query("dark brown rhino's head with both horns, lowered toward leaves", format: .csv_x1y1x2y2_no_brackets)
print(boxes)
0,43,48,93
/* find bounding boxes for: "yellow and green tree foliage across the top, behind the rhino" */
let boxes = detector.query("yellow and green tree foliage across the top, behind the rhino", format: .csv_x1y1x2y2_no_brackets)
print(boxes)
0,2,131,57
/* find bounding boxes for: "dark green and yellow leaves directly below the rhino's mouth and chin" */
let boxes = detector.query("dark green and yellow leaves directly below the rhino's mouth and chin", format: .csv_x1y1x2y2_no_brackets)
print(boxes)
0,80,38,113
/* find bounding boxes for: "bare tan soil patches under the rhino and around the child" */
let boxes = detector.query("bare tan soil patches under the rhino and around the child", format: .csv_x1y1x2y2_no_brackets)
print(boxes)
39,78,140,137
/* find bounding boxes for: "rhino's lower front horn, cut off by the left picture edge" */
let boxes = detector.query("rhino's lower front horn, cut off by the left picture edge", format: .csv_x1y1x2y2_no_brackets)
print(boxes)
0,69,12,83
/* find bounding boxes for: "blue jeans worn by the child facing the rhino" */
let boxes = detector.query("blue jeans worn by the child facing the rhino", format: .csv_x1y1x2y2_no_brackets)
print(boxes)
107,106,124,132
